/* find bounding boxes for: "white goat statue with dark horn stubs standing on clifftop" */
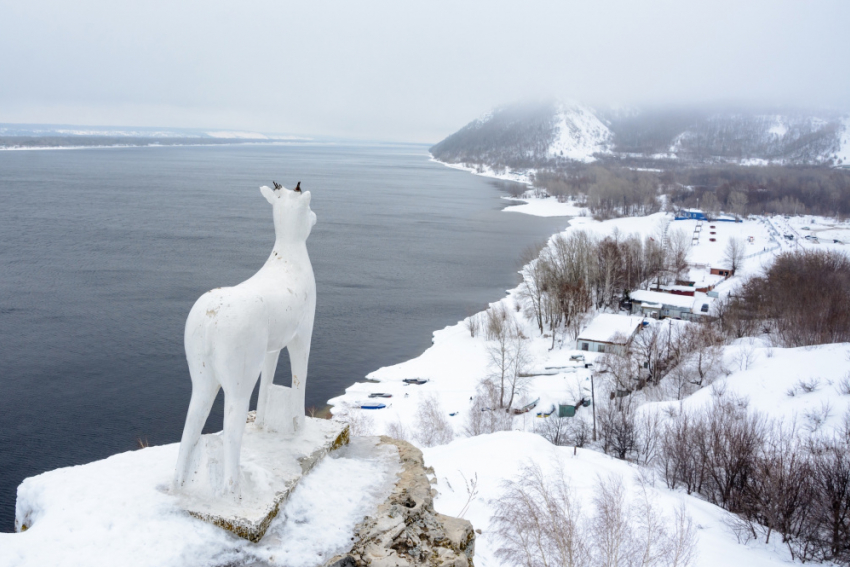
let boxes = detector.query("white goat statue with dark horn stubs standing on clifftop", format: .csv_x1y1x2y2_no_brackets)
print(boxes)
174,184,316,500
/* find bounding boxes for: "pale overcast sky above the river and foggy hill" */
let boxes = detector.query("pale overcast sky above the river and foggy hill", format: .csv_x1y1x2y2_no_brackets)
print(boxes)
0,0,850,142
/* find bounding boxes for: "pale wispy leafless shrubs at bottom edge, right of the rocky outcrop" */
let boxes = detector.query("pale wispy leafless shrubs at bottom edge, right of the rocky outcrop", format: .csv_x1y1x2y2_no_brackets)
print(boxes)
492,465,697,567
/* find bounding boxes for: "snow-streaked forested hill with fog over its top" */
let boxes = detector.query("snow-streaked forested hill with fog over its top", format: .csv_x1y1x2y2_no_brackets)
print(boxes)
431,101,850,169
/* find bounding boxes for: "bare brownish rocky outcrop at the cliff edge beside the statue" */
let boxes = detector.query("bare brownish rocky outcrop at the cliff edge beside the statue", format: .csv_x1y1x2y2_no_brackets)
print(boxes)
325,437,475,567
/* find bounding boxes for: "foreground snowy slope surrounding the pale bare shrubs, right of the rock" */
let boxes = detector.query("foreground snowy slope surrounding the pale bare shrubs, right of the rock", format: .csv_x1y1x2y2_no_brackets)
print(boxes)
424,431,800,567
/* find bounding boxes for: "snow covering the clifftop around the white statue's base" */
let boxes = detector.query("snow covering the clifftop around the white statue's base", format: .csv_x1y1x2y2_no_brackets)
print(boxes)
0,438,400,567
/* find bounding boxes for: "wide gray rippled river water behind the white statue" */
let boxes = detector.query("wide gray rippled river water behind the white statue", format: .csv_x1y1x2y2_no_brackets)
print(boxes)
0,145,566,531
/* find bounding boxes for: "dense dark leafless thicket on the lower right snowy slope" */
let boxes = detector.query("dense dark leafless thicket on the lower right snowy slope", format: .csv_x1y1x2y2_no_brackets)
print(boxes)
656,396,850,564
